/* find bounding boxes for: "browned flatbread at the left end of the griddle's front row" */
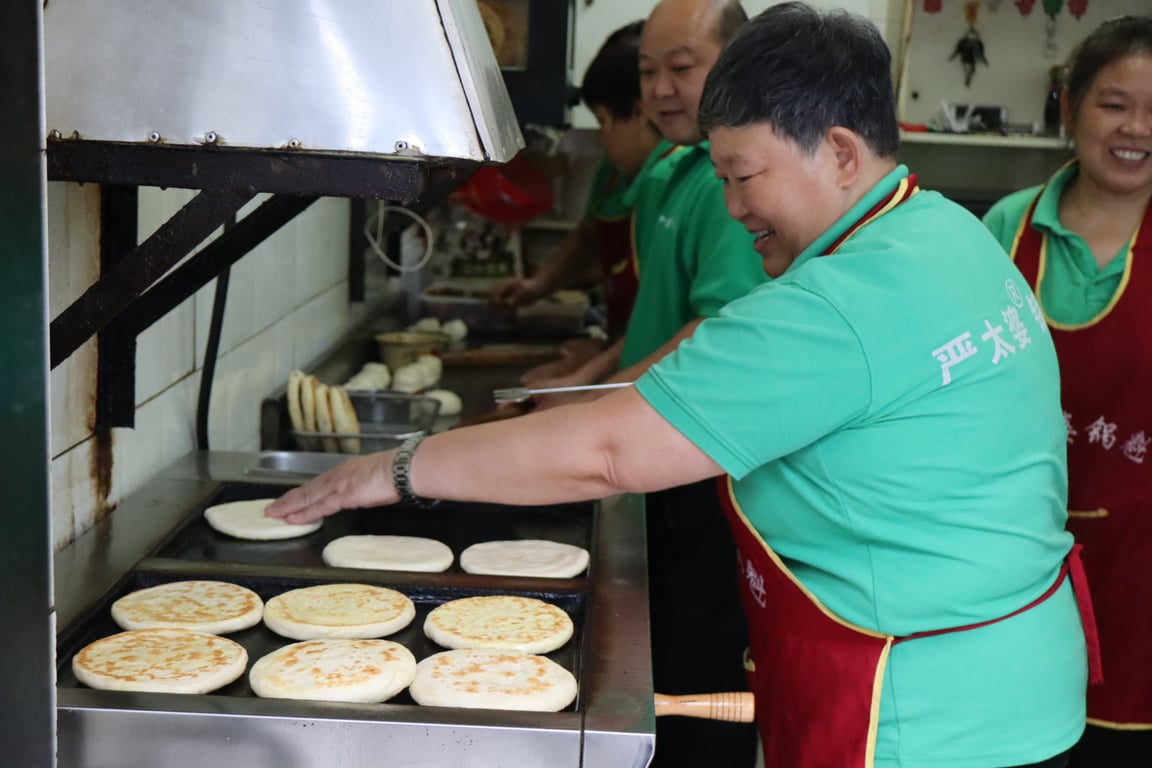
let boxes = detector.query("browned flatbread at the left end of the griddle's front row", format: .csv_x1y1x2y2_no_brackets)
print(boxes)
73,629,248,693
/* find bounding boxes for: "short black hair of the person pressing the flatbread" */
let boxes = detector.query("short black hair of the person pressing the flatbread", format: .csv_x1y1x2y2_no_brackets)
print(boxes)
698,2,900,157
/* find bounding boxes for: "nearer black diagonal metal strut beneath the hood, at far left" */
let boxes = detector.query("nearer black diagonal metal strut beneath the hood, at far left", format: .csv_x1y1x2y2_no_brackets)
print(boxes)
51,184,251,368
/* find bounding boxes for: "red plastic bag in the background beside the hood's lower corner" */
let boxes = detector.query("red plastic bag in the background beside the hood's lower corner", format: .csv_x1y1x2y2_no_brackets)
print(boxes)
453,154,554,225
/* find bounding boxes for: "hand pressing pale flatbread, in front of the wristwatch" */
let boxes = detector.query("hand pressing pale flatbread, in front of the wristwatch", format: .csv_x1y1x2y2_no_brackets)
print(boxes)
264,450,400,524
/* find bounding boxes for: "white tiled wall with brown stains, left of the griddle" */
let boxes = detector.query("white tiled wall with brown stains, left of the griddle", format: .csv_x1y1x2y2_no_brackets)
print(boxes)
48,184,366,548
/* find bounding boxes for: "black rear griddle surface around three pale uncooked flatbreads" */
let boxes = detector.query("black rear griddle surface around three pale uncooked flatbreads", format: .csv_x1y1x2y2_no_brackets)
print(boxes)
153,484,596,578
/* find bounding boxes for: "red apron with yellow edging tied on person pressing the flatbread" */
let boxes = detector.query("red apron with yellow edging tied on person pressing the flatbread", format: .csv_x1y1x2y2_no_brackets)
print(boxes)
720,476,1099,768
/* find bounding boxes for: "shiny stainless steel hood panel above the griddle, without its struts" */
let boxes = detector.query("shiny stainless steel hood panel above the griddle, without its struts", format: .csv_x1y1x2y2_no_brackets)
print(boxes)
44,0,523,168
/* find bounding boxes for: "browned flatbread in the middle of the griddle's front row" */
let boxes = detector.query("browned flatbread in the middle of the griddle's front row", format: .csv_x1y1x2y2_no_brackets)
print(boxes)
248,638,416,704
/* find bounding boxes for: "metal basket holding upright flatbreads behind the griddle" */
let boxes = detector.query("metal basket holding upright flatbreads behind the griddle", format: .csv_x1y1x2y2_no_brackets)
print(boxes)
291,389,440,454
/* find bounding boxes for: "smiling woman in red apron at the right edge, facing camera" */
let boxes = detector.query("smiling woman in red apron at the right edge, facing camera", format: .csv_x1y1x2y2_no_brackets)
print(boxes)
985,16,1152,768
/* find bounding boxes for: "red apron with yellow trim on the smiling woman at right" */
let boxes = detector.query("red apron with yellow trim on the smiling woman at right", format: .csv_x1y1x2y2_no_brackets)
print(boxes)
1011,186,1152,729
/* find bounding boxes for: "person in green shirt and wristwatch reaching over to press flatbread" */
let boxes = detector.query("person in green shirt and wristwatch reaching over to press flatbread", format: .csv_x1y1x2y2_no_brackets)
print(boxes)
268,2,1089,768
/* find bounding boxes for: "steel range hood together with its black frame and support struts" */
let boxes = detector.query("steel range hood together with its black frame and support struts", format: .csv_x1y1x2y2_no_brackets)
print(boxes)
44,0,524,375
